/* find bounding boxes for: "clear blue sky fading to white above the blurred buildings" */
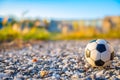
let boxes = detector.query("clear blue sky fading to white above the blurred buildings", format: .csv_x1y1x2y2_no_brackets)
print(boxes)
0,0,120,19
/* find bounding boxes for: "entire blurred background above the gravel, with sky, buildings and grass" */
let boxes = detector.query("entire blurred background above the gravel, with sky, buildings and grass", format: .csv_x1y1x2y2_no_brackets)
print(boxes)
0,0,120,43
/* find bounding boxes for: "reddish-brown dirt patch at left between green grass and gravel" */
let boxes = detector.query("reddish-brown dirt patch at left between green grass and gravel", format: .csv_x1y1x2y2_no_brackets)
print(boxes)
0,40,43,52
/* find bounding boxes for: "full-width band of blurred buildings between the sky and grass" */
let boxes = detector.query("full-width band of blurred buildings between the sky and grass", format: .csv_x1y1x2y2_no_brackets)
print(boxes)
0,16,120,33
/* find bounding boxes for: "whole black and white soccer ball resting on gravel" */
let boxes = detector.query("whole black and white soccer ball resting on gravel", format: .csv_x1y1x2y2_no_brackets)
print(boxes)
85,39,114,67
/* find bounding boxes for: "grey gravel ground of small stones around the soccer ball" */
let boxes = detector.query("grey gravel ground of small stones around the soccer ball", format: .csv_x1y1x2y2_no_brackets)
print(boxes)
0,40,120,80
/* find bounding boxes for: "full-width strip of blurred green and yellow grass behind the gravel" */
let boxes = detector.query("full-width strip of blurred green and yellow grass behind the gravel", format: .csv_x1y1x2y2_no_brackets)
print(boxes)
0,26,120,42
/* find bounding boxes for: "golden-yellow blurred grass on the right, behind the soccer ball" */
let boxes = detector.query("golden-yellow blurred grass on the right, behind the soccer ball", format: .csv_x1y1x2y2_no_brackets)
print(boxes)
55,29,120,40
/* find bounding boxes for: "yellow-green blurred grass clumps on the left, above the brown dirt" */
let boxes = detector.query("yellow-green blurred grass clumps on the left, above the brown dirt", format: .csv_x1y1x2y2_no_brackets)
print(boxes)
0,27,50,42
